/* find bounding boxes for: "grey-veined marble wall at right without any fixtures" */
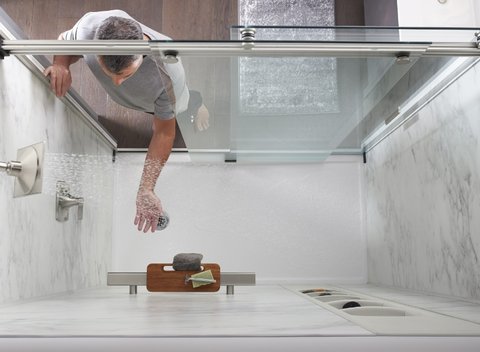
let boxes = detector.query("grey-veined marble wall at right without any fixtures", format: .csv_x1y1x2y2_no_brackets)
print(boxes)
364,58,480,299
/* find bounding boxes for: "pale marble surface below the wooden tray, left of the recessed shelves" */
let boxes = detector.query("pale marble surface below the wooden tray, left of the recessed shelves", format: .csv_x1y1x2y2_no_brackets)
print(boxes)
0,285,372,337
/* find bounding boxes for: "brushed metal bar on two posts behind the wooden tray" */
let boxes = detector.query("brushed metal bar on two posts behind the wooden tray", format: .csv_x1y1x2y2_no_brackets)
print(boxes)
107,272,256,295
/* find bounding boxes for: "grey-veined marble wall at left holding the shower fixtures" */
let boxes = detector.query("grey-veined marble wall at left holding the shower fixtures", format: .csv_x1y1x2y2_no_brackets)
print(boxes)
0,56,113,303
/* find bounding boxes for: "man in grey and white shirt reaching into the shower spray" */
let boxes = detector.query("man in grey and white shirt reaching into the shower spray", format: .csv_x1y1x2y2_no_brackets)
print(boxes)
45,10,208,232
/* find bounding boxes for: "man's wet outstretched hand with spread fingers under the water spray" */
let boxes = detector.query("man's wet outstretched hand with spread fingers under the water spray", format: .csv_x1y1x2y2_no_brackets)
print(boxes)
135,190,162,233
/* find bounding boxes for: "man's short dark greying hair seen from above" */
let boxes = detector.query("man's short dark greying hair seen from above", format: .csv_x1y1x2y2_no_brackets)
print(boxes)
95,16,143,74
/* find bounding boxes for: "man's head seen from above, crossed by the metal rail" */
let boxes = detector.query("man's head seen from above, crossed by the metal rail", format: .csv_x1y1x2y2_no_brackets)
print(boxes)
95,16,144,85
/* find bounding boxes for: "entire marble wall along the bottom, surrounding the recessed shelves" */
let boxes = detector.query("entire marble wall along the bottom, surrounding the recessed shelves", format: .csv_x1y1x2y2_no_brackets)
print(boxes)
0,284,480,352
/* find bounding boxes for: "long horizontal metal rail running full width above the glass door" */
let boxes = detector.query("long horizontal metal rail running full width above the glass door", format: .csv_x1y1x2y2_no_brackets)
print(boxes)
1,40,480,57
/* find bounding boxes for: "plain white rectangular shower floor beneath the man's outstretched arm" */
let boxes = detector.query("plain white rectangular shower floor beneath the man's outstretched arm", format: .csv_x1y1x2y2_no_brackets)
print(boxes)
112,153,366,283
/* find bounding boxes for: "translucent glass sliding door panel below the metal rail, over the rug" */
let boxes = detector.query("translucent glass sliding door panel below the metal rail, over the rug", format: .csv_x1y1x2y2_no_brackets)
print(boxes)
178,56,409,161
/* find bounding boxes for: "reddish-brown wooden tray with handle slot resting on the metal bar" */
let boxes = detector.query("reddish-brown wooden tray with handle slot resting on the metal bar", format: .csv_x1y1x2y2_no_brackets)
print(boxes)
147,263,220,292
